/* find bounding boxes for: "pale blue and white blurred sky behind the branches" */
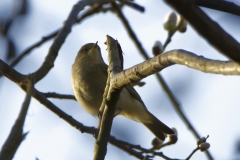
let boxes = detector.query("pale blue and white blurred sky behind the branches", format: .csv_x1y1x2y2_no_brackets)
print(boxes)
0,0,240,160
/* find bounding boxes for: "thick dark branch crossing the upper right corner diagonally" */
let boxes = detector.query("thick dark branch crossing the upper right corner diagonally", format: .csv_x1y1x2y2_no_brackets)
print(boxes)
165,0,240,62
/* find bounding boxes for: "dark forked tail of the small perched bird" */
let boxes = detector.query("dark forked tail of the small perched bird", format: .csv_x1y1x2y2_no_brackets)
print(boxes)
141,112,174,141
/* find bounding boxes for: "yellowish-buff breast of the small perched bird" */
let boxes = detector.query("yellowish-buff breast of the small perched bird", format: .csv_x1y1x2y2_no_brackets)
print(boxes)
72,64,107,116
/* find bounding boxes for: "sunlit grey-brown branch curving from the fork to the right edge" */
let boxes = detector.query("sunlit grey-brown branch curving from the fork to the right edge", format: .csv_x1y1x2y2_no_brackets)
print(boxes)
111,50,240,88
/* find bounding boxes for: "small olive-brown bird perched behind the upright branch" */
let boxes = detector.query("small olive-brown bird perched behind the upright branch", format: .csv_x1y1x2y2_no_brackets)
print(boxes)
71,43,174,141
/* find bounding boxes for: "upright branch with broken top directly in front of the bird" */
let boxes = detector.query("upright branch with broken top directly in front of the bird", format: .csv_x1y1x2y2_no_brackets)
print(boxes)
94,35,121,160
